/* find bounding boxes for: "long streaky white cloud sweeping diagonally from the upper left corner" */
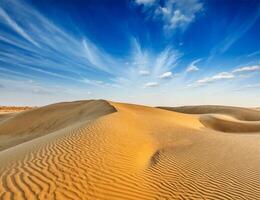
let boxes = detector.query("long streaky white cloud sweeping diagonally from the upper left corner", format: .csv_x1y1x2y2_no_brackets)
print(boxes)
0,0,121,85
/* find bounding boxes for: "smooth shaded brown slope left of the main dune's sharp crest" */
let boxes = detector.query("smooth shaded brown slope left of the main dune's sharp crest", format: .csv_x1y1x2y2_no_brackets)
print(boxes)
0,100,116,150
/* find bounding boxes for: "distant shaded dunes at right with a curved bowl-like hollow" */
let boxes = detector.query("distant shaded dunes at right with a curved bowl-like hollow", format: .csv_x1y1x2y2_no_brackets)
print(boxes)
160,106,260,133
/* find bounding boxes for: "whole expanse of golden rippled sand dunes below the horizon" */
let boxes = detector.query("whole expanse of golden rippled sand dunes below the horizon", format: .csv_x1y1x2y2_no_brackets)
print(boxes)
0,100,260,200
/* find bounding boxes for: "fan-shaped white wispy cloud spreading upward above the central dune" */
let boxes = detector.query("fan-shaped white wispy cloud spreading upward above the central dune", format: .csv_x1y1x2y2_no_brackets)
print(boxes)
113,38,181,87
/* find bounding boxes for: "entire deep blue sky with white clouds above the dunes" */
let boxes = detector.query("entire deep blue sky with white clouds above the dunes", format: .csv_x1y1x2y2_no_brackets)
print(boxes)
0,0,260,106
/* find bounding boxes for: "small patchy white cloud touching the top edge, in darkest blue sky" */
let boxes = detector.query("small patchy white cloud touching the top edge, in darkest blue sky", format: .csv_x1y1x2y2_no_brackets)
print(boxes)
135,0,203,30
